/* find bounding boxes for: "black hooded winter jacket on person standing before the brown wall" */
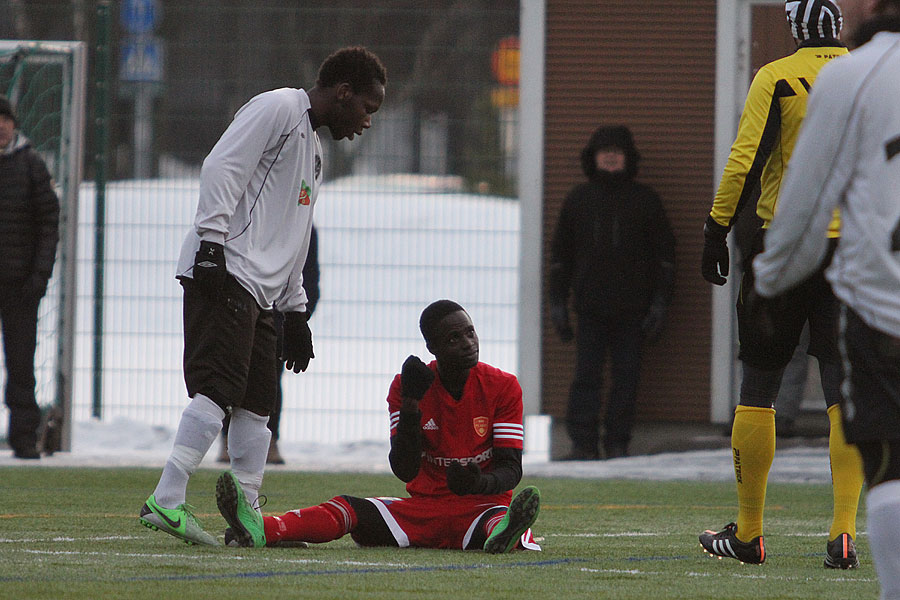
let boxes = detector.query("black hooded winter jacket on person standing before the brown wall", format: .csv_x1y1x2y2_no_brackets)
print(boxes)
549,126,675,319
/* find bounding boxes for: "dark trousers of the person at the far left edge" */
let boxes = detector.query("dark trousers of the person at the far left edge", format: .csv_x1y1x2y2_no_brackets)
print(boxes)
0,290,41,450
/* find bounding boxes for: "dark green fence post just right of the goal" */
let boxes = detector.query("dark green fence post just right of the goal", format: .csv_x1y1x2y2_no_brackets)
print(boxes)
93,0,112,419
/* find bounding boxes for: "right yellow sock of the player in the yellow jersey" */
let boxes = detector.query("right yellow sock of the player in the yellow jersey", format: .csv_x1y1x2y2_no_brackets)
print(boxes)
828,404,864,540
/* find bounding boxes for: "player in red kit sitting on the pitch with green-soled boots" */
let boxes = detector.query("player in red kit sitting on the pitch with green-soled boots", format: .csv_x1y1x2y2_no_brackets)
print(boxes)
216,300,540,554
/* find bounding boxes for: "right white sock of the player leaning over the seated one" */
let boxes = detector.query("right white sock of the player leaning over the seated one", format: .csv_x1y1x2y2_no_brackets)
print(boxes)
228,408,272,508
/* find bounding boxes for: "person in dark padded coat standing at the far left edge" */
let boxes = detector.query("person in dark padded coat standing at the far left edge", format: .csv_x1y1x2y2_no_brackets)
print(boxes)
0,96,59,458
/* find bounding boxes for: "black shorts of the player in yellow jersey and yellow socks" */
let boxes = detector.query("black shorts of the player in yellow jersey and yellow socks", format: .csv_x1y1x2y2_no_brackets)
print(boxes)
737,229,840,370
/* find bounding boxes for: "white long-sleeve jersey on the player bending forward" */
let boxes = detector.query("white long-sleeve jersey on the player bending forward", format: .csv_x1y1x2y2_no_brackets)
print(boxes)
178,88,322,312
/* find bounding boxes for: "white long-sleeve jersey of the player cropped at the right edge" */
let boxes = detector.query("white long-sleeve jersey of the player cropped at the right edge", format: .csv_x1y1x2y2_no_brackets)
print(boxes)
753,32,900,337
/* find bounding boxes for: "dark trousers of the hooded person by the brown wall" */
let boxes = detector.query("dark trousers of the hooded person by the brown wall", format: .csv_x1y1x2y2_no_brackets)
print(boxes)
566,315,644,453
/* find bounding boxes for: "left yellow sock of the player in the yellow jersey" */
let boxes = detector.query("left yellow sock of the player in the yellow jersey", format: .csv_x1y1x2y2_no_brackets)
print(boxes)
731,406,775,542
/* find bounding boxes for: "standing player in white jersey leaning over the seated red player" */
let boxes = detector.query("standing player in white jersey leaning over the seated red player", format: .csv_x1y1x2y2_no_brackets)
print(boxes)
140,47,387,545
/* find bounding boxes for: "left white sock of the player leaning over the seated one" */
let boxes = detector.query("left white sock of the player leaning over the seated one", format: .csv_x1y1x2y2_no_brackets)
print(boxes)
153,394,225,508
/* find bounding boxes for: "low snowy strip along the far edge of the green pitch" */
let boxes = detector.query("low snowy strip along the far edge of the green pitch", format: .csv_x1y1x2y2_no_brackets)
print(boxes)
0,418,831,483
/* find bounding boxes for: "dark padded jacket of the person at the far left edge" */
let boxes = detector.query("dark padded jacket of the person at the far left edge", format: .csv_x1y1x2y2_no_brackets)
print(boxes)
0,134,59,286
